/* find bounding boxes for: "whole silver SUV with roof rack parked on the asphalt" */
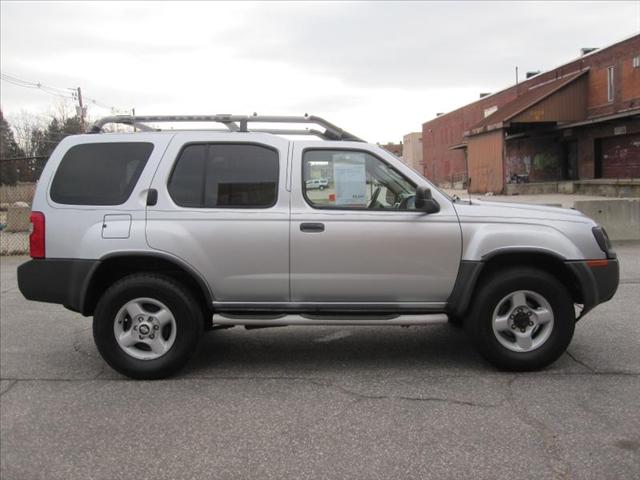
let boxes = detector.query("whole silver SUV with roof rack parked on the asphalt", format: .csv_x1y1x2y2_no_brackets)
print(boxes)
18,115,619,379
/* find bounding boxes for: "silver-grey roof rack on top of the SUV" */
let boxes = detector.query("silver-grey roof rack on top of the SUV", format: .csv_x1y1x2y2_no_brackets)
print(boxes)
90,114,364,142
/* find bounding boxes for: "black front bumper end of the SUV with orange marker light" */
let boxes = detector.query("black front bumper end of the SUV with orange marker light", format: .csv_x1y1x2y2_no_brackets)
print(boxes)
566,258,620,317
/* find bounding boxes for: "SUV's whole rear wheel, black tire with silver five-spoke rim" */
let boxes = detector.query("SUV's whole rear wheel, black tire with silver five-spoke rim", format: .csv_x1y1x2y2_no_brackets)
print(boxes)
93,274,204,379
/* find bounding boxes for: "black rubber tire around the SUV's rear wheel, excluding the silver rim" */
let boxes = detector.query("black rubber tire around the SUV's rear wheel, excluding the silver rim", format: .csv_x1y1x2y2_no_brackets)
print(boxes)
93,274,204,380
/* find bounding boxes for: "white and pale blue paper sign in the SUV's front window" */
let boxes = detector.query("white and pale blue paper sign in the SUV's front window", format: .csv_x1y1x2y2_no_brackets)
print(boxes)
333,153,367,206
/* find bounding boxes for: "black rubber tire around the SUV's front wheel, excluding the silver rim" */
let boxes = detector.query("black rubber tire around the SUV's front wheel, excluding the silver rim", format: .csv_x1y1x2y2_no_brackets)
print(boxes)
465,267,576,371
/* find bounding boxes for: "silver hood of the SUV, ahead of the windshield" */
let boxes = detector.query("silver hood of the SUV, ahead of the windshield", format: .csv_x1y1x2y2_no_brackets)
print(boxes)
454,200,593,223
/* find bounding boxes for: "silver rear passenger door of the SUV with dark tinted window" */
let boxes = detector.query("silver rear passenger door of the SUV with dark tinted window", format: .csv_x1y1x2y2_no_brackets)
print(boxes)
146,132,289,306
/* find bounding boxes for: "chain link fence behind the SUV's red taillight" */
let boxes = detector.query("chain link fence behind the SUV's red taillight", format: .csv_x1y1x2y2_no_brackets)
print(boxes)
0,157,46,256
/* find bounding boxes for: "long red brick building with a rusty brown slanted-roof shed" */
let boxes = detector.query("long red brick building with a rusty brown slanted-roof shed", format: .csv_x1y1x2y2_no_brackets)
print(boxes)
422,35,640,195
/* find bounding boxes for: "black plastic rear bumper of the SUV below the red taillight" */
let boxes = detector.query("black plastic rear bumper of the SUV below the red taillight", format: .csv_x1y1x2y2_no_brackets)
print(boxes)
18,258,100,312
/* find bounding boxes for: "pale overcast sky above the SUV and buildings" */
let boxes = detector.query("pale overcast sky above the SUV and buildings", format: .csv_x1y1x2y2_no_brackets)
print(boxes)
0,1,640,143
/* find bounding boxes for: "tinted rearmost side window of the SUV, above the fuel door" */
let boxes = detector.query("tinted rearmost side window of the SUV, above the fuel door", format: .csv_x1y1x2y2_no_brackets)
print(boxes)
50,142,153,205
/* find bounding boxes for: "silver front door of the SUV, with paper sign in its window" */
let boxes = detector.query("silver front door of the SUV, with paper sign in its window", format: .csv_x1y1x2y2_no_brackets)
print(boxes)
291,142,462,310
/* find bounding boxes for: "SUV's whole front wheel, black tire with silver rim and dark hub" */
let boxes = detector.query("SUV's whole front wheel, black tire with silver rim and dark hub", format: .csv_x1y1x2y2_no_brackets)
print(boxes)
466,268,575,371
